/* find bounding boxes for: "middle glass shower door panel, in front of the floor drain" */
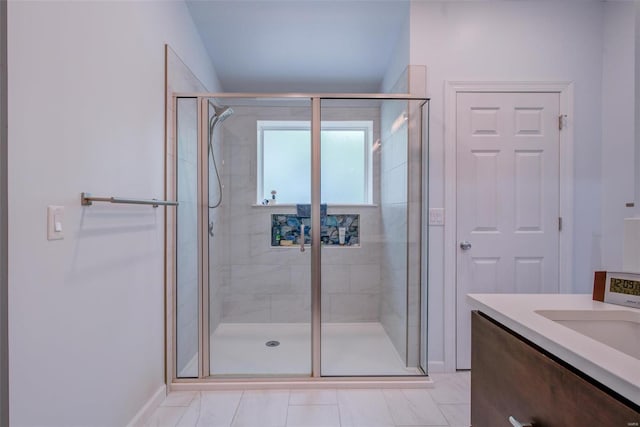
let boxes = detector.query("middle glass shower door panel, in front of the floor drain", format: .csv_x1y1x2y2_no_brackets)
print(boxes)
203,97,311,377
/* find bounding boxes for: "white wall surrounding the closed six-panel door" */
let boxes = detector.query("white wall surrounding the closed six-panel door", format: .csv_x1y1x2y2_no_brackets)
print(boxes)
410,1,603,369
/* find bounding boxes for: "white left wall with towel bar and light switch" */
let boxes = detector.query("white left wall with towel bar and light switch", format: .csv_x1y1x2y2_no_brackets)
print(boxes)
8,2,216,426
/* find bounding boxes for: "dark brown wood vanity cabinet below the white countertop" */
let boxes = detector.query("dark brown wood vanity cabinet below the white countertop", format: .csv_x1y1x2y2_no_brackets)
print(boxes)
471,311,640,427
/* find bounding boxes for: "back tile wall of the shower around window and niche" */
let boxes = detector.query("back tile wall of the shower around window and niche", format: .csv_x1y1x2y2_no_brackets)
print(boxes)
210,107,383,322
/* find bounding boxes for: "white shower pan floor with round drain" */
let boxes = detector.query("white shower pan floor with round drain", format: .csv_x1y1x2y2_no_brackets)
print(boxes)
210,322,421,376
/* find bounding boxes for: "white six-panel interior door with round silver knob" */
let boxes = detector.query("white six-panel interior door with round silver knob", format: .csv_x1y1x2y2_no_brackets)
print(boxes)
456,92,560,369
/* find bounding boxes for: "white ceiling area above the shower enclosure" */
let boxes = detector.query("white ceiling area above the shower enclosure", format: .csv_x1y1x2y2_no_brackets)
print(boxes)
187,0,409,92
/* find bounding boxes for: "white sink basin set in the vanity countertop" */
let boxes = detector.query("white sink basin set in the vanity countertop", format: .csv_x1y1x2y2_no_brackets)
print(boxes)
536,310,640,360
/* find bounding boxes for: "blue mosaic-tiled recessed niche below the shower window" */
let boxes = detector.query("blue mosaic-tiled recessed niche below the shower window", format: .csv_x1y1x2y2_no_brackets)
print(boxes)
271,214,360,246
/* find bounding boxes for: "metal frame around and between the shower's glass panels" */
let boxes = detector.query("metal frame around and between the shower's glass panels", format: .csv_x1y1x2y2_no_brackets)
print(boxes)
165,93,431,390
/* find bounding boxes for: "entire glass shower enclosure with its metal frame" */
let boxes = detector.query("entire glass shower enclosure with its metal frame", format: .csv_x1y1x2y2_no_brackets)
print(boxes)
167,94,428,384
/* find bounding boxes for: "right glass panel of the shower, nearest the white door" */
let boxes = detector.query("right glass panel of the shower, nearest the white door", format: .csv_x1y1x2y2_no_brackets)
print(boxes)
320,99,424,376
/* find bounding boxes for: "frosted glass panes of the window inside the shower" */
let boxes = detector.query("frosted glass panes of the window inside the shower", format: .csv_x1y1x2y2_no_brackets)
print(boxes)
257,121,373,204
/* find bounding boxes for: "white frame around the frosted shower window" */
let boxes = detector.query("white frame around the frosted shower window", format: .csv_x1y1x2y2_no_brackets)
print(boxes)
255,120,374,206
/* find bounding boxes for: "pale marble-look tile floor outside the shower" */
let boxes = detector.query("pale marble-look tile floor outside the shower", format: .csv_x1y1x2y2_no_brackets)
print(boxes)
145,372,470,427
